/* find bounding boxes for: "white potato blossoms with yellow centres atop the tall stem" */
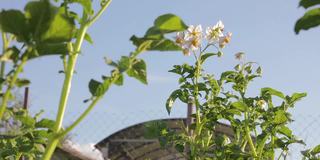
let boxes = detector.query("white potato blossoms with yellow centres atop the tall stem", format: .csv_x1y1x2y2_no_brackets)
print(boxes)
176,21,232,55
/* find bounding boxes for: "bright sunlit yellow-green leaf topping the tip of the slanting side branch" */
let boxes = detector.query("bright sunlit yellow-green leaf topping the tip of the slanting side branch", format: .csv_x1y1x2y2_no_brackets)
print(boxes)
154,14,188,33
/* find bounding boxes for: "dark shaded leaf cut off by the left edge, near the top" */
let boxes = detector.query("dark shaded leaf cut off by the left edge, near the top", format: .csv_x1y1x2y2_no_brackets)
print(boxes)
0,10,28,41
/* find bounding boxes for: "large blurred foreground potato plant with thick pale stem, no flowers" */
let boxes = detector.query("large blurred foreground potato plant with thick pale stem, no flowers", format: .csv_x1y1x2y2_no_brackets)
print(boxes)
0,0,186,160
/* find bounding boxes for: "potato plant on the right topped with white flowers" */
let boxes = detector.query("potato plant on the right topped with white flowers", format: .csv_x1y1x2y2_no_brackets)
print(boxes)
142,21,306,160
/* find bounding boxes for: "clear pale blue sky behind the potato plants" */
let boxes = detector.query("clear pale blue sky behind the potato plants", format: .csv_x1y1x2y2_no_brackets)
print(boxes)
0,0,320,150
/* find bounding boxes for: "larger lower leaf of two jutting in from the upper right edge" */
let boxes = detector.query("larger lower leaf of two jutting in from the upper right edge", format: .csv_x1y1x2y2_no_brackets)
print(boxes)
294,8,320,34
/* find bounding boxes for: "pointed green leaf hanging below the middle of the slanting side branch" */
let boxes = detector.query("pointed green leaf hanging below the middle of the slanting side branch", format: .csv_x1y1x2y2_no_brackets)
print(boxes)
127,59,148,84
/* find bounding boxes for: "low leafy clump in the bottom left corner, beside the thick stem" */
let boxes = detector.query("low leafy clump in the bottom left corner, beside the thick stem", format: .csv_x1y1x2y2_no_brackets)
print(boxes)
0,106,55,159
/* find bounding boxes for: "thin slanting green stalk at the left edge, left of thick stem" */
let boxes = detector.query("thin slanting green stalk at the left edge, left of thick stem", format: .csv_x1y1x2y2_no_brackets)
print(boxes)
0,56,28,120
